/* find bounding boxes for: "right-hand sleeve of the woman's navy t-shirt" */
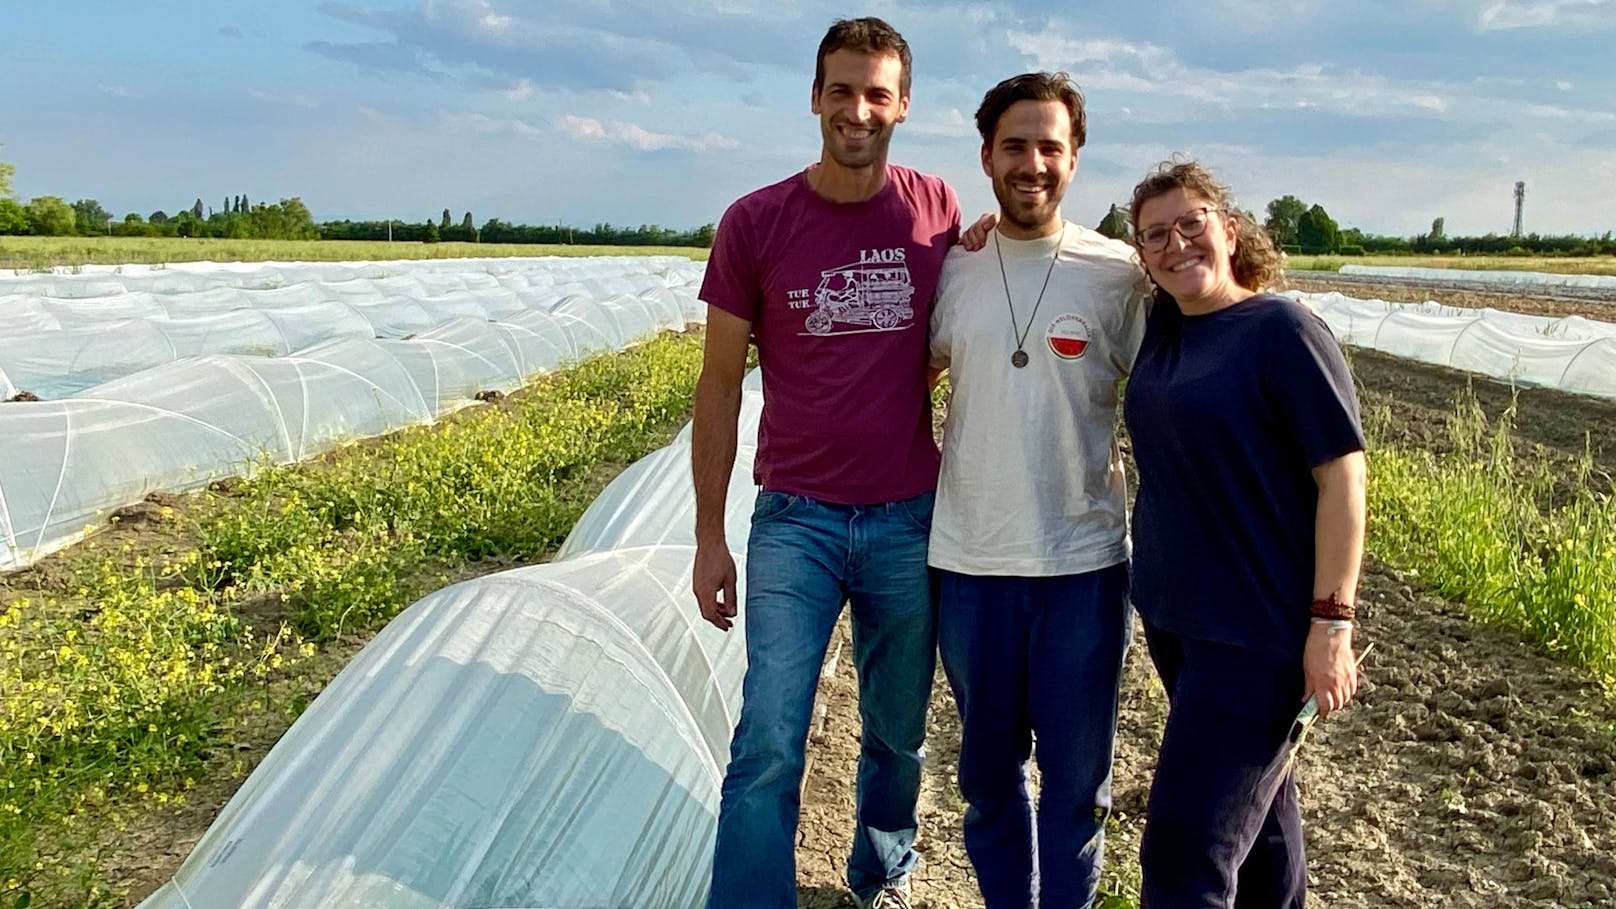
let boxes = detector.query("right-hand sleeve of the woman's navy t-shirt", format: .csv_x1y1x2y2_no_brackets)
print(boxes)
1264,306,1364,467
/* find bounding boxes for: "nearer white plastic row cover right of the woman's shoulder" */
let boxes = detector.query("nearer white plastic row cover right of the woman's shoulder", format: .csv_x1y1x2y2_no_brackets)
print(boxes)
1291,293,1616,398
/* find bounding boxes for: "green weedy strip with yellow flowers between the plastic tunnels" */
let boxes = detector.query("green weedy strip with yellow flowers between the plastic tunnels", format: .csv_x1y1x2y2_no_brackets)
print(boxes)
0,328,701,907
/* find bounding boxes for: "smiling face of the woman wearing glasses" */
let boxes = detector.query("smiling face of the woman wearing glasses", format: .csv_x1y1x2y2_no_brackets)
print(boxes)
1138,189,1251,314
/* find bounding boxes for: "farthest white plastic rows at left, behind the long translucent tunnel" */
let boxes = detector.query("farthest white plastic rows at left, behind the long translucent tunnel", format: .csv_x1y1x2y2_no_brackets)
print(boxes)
0,257,705,400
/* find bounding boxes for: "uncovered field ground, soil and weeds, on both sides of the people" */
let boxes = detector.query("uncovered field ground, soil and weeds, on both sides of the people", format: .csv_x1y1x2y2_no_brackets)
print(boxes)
0,255,1616,909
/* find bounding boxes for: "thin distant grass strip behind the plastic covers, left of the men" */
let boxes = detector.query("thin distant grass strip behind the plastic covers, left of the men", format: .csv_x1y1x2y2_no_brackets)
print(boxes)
0,236,708,270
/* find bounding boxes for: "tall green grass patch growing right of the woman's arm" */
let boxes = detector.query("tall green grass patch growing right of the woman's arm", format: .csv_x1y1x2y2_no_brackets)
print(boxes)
1367,395,1616,686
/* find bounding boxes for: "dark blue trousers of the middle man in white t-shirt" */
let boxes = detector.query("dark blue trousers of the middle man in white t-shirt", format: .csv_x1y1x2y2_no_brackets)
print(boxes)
937,564,1131,909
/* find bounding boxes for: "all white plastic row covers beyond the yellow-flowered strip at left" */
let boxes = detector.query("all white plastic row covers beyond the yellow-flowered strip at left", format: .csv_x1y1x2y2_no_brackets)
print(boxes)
0,259,701,571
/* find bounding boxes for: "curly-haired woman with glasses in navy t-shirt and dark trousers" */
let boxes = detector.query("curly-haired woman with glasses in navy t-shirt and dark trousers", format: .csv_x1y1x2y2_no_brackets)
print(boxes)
1125,160,1364,909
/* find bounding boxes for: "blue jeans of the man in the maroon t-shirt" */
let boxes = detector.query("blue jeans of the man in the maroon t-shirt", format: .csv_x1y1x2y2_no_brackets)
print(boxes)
708,490,937,909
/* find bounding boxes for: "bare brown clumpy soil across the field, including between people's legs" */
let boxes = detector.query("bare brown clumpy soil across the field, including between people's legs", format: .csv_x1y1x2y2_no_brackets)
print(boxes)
31,280,1616,909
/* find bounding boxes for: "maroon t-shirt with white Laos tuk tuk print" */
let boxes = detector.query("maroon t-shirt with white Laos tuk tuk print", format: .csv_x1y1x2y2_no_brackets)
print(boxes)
701,165,960,505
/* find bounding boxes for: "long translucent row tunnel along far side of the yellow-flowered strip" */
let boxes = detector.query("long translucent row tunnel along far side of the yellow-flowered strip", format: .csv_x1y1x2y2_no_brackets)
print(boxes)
0,257,707,569
